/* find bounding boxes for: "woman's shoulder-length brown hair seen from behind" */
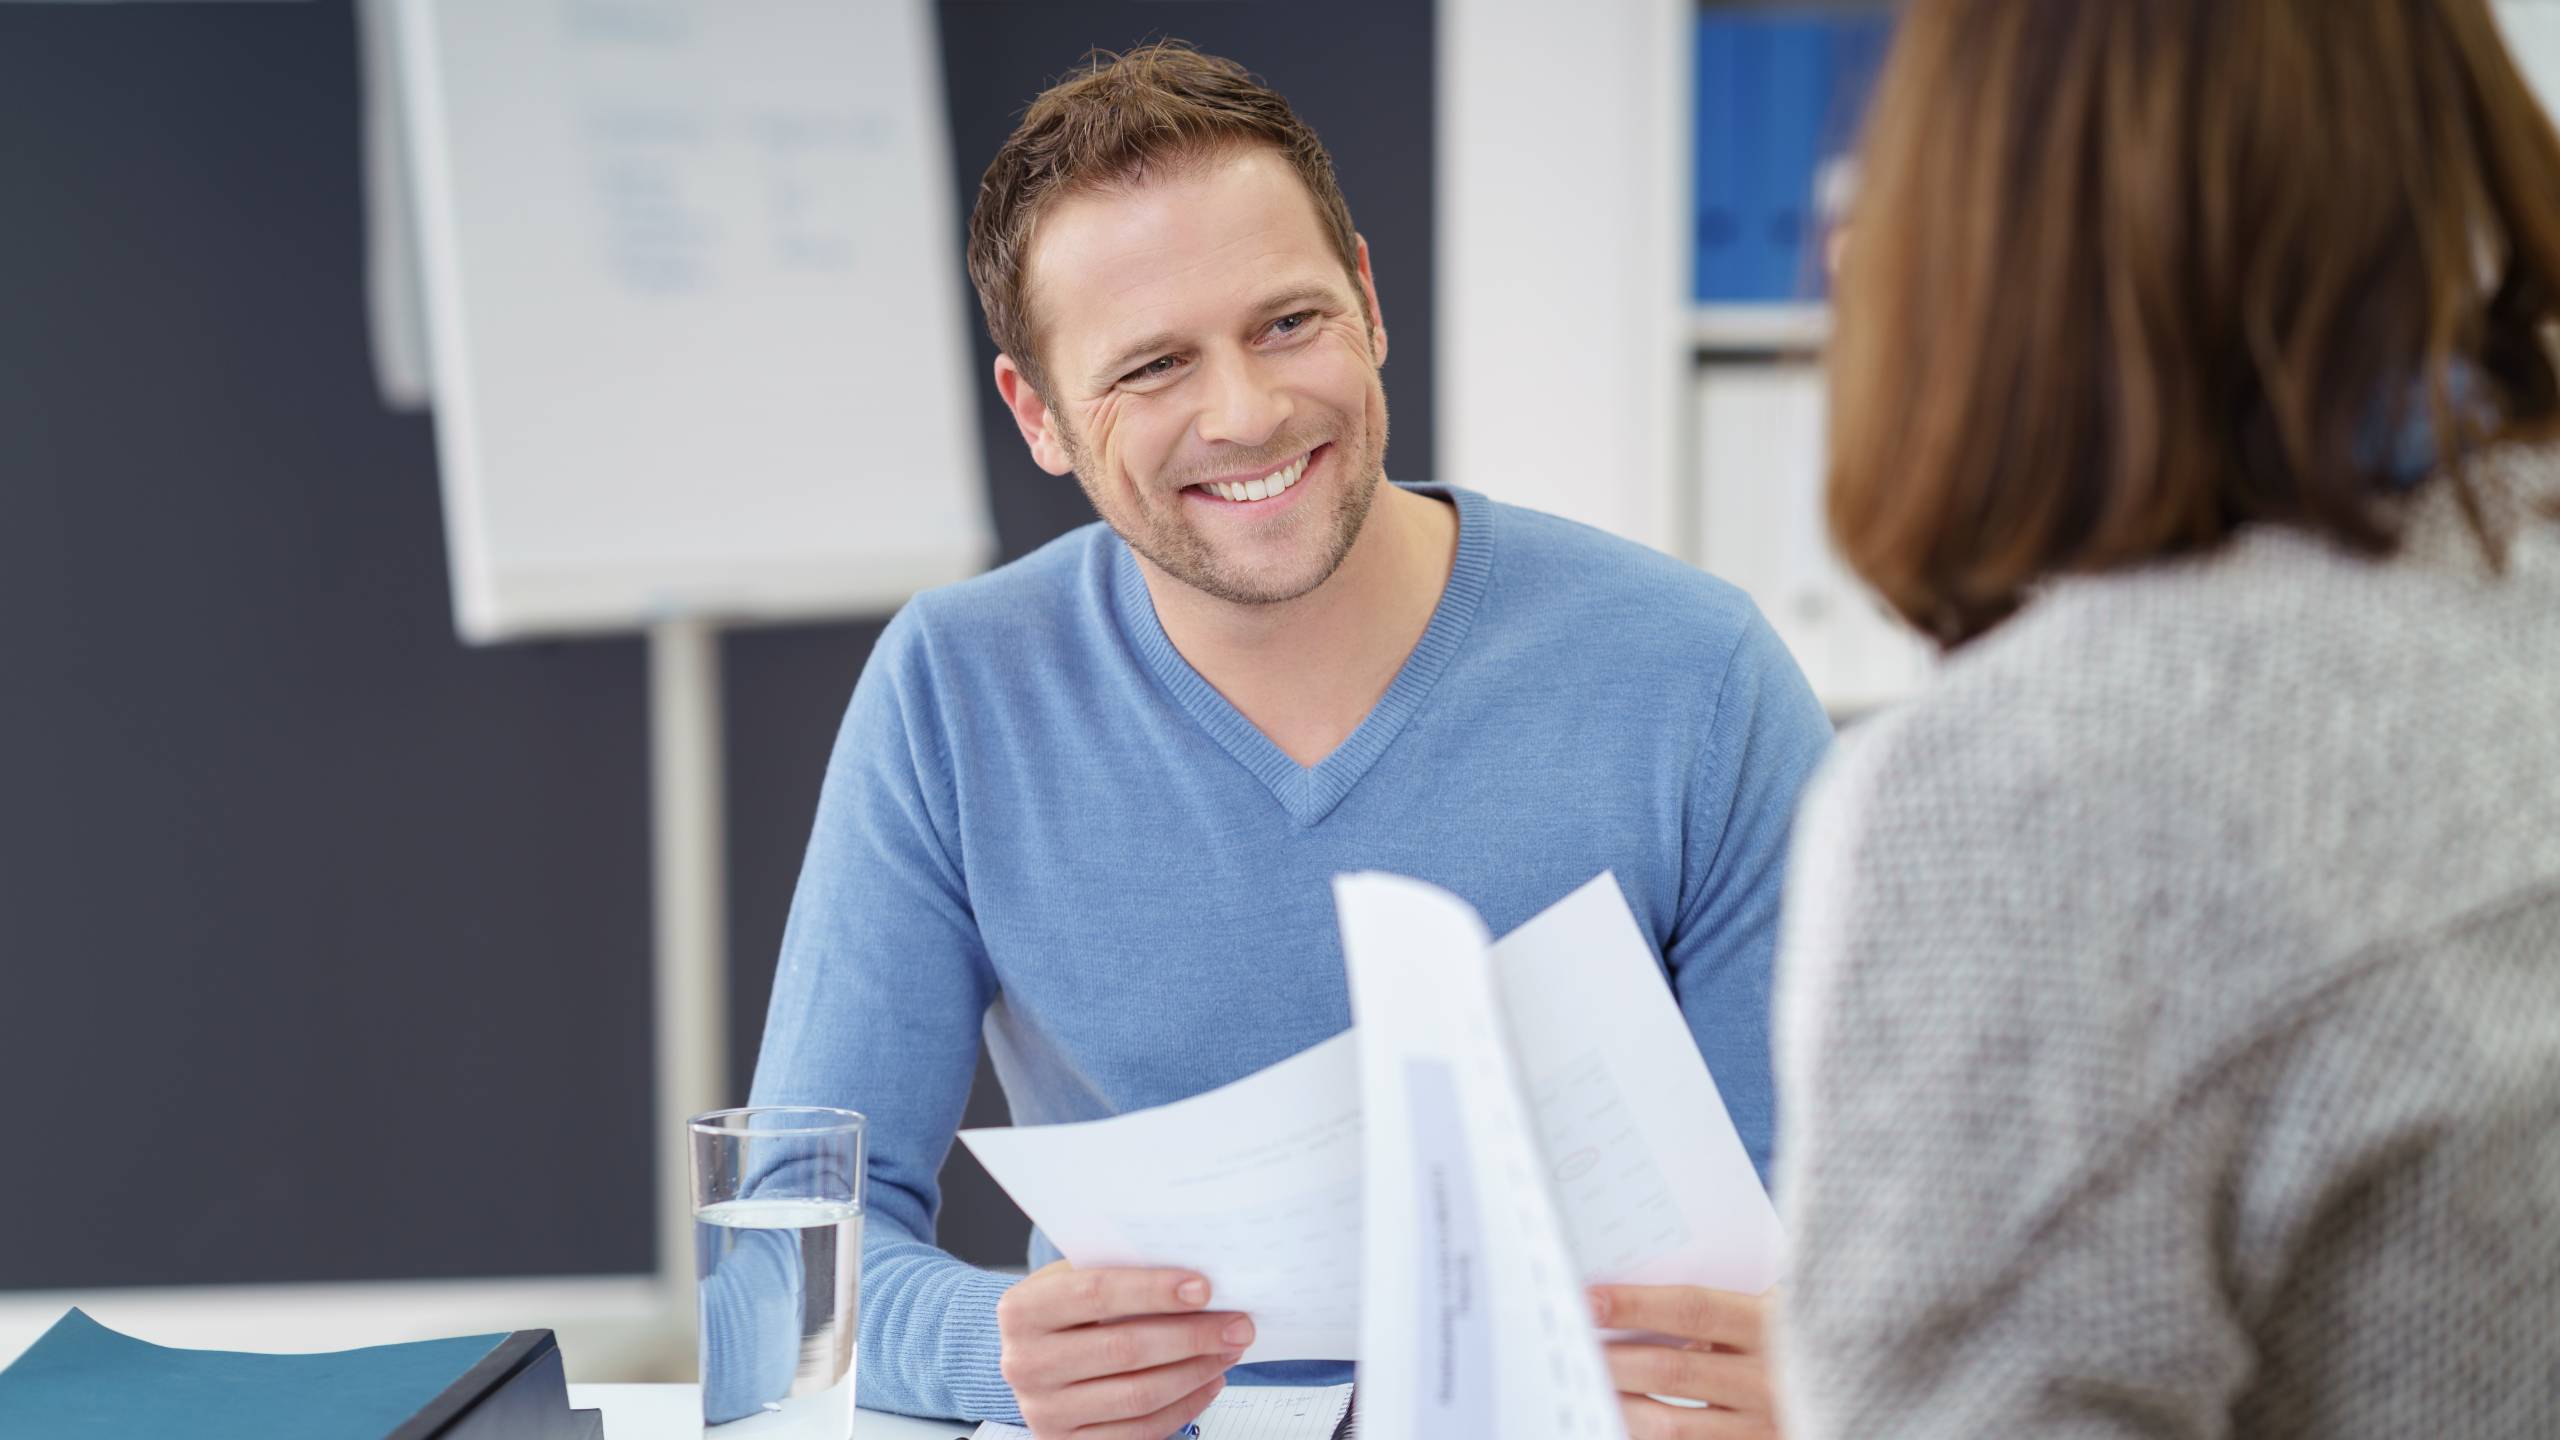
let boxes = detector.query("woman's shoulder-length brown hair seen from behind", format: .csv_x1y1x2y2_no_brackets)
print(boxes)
1830,0,2560,646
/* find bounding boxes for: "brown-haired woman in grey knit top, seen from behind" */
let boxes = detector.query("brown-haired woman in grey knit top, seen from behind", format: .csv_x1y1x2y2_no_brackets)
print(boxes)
1777,0,2560,1437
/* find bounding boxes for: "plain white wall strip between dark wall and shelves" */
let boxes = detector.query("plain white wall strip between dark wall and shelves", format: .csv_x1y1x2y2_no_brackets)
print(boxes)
1431,0,1695,553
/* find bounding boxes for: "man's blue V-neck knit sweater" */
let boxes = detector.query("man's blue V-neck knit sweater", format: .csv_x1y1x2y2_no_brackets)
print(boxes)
753,487,1830,1420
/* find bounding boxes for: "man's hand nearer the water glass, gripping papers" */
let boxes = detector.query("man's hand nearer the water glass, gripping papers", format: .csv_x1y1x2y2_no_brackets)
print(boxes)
996,1261,1254,1440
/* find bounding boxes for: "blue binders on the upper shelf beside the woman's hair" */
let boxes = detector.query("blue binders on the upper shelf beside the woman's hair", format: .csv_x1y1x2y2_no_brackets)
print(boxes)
1695,8,1892,305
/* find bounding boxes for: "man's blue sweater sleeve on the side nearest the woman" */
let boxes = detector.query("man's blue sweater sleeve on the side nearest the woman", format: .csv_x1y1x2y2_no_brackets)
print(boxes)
1664,599,1830,1184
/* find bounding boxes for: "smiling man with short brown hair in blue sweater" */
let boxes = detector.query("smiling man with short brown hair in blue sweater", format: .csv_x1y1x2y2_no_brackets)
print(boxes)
755,44,1830,1440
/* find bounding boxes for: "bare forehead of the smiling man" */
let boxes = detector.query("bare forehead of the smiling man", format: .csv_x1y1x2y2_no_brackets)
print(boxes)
1024,149,1349,366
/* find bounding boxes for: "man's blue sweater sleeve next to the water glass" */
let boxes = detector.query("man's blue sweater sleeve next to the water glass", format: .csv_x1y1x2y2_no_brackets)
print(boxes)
742,605,1019,1420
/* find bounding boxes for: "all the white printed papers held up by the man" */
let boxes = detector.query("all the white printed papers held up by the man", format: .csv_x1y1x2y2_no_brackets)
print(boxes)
963,874,1784,1440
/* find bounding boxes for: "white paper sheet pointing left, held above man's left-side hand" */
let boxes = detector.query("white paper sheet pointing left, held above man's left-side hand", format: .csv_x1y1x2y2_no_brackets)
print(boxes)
960,1035,1359,1363
